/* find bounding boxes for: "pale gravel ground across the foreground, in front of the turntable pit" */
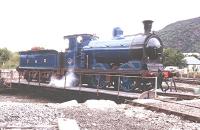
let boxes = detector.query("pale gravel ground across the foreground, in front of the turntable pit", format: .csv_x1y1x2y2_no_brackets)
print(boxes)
0,100,200,130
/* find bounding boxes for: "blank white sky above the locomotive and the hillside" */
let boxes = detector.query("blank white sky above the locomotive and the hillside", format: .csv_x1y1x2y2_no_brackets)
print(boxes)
0,0,200,51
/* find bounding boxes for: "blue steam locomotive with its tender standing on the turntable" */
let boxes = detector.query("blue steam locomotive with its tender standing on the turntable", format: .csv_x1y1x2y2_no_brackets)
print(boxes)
17,20,163,91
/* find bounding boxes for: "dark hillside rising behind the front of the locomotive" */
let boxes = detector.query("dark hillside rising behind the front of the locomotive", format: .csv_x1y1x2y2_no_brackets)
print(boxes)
158,17,200,53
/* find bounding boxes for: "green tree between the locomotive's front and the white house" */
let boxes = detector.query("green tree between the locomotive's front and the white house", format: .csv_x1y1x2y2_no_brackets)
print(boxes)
163,48,186,68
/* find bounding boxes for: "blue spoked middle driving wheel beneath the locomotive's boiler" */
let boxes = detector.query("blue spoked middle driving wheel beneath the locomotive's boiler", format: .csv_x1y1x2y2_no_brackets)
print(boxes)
120,77,136,92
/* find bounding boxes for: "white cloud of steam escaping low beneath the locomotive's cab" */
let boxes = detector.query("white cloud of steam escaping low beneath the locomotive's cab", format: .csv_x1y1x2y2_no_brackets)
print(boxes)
49,69,78,88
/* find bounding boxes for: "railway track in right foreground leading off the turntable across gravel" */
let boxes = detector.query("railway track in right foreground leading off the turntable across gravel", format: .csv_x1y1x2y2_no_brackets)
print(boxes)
126,99,200,123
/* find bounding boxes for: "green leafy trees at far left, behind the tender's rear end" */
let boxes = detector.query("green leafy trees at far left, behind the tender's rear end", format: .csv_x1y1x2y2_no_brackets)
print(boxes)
0,48,19,69
